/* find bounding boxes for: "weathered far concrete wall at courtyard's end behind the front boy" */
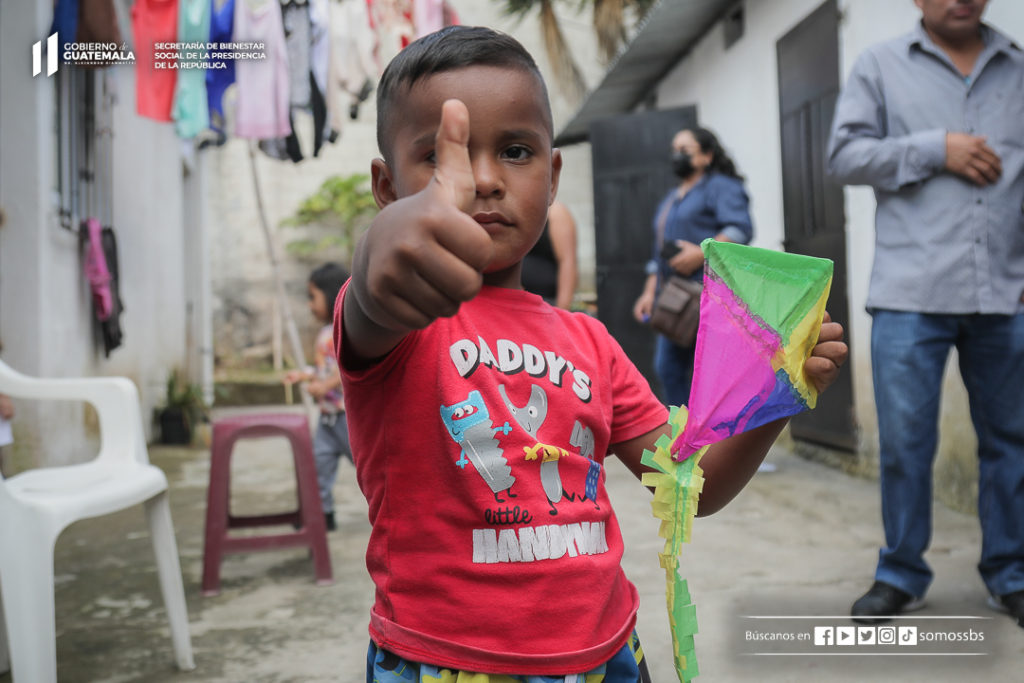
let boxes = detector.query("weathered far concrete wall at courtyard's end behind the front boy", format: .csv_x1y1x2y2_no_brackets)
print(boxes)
203,0,604,368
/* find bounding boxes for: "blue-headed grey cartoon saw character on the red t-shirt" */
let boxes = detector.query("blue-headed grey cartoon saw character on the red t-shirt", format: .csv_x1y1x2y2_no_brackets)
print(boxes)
441,390,515,503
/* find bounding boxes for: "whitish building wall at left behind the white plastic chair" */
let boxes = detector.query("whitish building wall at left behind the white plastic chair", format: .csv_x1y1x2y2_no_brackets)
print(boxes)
0,2,202,465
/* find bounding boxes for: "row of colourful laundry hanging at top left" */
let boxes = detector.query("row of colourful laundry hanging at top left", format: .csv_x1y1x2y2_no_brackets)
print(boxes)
51,0,458,162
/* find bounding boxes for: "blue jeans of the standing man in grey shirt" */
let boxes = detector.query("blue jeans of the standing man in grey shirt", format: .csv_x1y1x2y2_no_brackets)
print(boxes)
871,310,1024,597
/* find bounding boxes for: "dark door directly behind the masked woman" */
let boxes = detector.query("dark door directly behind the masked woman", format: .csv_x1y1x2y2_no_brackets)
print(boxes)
590,106,697,393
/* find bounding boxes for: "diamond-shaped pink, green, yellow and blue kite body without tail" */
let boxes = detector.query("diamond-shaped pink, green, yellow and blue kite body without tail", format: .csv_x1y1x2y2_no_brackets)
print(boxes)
673,240,833,460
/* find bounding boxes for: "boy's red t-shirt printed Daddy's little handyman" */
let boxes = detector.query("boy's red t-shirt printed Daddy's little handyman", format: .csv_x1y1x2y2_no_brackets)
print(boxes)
334,286,668,675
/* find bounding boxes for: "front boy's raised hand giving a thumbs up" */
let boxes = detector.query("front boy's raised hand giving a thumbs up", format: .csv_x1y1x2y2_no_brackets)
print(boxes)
345,99,494,348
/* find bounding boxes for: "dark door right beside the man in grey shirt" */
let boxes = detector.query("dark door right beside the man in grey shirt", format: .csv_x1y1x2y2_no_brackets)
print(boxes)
776,0,857,451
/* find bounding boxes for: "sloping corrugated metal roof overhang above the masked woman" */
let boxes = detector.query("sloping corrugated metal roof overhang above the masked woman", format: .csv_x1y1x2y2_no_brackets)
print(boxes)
555,0,736,146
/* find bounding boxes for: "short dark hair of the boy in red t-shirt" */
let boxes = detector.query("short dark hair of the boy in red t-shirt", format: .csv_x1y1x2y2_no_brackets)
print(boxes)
377,26,554,161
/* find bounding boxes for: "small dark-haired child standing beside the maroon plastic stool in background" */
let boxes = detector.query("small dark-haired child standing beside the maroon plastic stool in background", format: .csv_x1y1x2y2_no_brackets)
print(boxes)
285,263,353,531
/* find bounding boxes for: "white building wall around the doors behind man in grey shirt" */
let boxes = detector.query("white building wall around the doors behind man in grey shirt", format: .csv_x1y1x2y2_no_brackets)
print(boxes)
657,0,1024,509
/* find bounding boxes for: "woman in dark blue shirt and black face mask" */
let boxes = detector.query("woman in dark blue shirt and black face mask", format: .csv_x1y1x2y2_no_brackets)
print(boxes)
633,128,754,405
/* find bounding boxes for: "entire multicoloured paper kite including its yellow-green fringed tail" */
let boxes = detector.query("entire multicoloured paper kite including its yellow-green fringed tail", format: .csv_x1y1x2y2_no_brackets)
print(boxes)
642,240,833,683
